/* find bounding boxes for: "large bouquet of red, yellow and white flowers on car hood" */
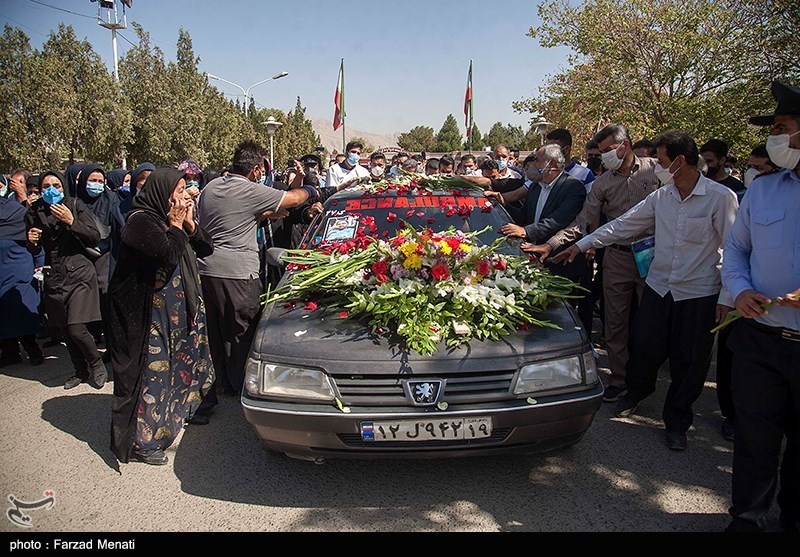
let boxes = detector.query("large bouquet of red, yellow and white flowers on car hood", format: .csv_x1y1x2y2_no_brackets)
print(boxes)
265,223,576,355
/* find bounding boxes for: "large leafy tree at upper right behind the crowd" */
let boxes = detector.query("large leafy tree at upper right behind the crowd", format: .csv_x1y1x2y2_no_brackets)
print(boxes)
513,0,800,161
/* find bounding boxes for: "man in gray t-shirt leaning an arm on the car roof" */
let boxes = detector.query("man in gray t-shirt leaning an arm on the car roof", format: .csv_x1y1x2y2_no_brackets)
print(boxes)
192,141,317,416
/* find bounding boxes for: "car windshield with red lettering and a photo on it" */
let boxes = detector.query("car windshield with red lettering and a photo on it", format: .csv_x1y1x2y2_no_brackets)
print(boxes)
306,193,520,255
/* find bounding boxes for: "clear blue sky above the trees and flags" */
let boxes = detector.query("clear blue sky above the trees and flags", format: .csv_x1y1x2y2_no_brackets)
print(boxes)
0,0,569,135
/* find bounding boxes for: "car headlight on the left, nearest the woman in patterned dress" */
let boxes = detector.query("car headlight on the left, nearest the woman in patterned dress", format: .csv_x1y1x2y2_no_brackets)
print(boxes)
245,358,335,402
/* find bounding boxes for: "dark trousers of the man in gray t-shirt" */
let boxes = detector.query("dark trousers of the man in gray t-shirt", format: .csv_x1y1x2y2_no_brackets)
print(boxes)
200,276,261,396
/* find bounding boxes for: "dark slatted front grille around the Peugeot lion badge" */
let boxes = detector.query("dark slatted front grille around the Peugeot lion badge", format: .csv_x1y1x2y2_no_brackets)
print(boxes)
332,370,516,407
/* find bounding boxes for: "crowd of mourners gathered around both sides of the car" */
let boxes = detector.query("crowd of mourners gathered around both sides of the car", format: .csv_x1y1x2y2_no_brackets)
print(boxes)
0,78,800,530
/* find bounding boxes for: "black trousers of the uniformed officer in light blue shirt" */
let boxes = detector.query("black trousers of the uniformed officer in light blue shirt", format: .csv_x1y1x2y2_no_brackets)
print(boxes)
728,319,800,530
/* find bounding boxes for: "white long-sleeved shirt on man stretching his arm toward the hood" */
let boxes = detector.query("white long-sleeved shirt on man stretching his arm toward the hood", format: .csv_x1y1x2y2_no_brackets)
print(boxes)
577,175,739,307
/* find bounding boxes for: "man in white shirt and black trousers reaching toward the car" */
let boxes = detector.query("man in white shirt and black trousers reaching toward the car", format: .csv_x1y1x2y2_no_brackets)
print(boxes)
553,131,739,450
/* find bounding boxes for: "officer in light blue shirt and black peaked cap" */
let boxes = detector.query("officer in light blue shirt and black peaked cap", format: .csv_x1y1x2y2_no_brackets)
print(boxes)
722,81,800,533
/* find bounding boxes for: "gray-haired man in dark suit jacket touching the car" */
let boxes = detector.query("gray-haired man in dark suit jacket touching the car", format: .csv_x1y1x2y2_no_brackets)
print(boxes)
486,145,592,336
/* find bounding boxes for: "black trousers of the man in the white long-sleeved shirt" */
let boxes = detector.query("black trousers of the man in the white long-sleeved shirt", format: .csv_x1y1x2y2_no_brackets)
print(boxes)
625,285,718,432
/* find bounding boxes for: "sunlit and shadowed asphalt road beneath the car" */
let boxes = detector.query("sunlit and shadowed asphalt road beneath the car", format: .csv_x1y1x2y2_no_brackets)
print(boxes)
0,332,778,532
